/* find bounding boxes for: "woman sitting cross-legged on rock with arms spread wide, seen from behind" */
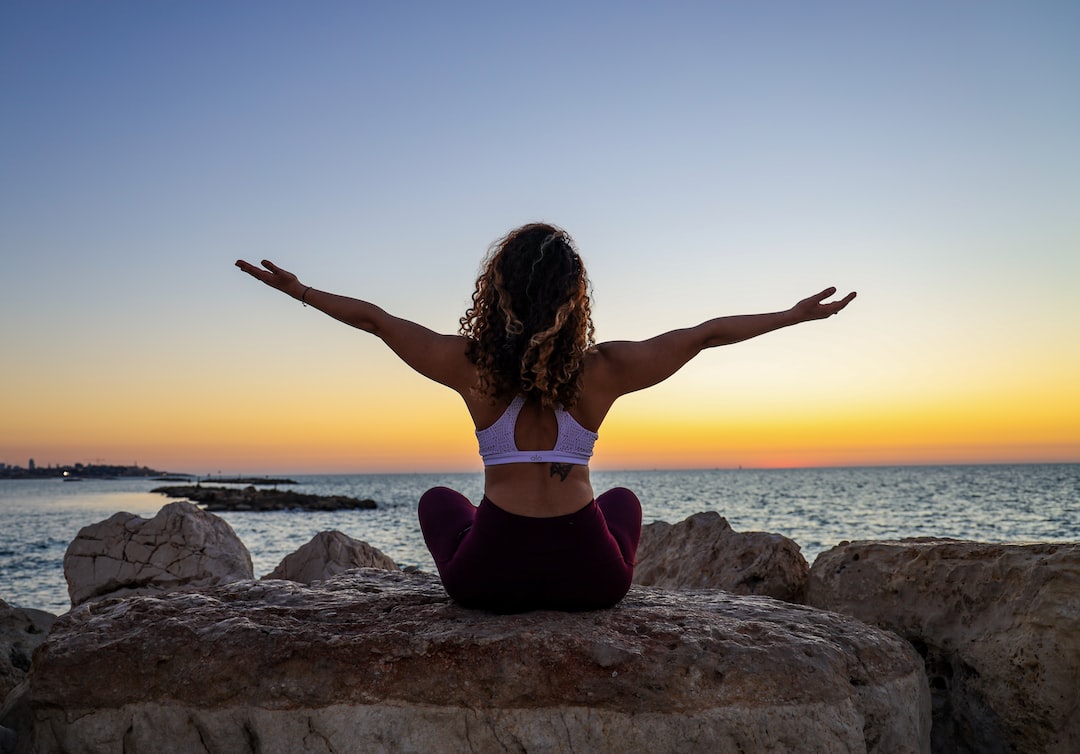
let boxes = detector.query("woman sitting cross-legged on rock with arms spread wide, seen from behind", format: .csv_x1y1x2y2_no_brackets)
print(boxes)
237,223,855,611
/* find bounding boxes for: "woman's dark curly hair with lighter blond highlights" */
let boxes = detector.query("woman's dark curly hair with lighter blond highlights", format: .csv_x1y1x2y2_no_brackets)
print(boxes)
460,223,595,408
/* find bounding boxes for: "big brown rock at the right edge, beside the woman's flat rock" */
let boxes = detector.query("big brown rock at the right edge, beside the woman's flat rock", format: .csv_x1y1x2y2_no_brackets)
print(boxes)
807,539,1080,752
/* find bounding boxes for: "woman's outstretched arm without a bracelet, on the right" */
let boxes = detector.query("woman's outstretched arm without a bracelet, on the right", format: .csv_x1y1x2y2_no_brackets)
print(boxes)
590,287,855,402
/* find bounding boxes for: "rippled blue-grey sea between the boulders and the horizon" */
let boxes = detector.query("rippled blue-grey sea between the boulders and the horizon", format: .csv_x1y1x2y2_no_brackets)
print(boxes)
0,463,1080,615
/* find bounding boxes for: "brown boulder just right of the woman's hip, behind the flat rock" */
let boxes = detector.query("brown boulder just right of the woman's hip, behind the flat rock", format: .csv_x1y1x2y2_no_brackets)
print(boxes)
634,511,810,602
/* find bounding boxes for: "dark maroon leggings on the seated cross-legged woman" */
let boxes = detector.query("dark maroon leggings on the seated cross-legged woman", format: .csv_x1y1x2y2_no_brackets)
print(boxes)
419,487,642,612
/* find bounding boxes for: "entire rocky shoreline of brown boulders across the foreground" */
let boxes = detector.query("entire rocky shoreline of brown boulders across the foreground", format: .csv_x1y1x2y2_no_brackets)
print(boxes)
0,502,1080,754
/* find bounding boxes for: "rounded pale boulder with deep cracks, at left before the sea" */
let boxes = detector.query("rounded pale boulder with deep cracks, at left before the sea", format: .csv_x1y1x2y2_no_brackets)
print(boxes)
64,502,253,606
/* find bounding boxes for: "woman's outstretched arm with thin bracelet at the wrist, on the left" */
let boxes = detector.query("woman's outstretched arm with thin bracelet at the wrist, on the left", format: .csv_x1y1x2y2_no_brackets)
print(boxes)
237,259,475,392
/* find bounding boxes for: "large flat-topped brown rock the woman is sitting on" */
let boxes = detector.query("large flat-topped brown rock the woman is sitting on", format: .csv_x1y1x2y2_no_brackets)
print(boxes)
14,569,930,754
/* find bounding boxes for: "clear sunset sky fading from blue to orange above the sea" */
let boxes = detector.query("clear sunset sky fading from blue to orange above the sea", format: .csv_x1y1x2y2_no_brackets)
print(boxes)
0,0,1080,473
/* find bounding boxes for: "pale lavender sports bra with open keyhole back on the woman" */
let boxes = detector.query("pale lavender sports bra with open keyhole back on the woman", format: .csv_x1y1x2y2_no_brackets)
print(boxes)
476,395,599,466
